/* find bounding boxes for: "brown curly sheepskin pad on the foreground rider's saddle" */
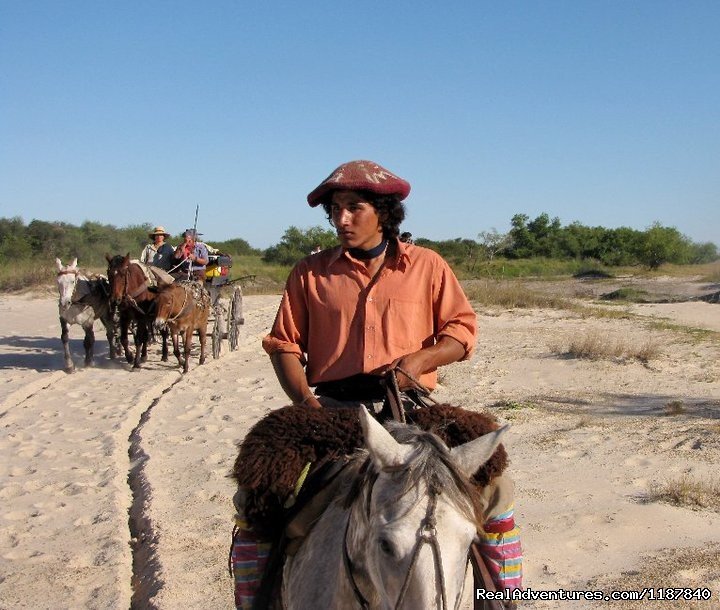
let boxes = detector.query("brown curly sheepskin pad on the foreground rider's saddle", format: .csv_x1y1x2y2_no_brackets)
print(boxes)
231,404,508,533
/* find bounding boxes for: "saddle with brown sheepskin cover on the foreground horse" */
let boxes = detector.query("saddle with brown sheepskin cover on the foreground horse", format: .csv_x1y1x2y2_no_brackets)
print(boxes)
232,376,512,608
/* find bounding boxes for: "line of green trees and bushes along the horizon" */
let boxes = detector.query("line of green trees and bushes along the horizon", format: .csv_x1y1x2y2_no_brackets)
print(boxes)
0,213,718,270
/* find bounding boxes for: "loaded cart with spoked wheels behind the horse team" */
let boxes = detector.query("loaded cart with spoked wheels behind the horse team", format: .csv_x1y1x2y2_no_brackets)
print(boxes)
205,254,255,358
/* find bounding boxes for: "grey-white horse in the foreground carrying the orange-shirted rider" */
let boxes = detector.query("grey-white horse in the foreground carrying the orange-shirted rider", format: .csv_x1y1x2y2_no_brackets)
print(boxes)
282,409,508,610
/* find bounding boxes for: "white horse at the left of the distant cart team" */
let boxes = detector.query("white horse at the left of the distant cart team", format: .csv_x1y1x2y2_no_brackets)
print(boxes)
55,258,118,373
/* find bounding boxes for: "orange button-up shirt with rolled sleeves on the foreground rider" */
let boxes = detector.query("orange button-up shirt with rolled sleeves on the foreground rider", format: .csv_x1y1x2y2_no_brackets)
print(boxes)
263,242,477,389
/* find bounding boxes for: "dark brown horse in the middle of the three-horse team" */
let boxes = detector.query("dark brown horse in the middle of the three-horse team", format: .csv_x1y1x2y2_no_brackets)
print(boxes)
105,253,168,369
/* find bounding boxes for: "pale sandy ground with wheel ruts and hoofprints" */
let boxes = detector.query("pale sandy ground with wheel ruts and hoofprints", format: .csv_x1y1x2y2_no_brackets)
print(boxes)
0,280,720,610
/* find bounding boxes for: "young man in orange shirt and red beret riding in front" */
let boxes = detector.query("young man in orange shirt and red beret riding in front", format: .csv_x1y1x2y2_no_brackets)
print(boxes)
238,161,520,604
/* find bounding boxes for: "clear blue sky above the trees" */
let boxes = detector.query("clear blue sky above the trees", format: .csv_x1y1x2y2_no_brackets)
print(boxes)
0,0,720,248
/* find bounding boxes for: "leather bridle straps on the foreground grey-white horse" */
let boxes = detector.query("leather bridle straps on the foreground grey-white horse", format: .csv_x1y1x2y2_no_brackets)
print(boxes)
343,476,462,610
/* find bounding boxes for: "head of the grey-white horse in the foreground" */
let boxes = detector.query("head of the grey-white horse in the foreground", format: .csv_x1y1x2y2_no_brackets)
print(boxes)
348,409,507,609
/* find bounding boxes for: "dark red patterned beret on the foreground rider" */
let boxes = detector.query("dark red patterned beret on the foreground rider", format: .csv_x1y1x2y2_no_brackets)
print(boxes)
308,161,410,207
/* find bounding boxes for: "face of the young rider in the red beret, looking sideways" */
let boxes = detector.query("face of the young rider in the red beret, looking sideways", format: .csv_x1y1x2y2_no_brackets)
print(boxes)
330,191,382,250
